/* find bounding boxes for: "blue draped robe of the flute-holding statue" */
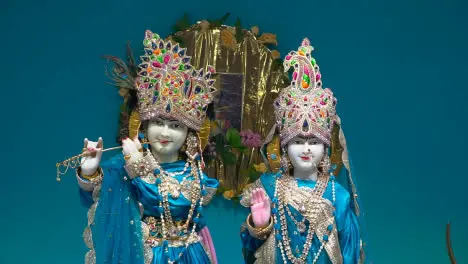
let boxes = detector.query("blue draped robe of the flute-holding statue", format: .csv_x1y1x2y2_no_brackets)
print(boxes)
80,155,218,264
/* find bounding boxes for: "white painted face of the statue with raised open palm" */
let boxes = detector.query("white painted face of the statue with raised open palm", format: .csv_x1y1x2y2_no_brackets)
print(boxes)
288,136,325,173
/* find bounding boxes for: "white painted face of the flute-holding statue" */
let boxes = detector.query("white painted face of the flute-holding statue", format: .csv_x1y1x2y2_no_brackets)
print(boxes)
147,118,188,156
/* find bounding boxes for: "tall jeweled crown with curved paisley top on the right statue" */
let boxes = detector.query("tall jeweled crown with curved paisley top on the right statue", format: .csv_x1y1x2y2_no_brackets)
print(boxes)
274,38,336,146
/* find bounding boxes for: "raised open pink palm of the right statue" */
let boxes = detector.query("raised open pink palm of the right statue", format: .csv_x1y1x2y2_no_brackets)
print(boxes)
250,188,271,228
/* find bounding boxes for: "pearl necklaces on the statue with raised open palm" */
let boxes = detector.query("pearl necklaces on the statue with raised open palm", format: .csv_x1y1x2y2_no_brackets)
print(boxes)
272,169,336,264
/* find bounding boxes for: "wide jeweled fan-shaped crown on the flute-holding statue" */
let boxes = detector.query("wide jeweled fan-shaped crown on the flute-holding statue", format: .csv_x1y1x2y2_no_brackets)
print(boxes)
136,30,216,131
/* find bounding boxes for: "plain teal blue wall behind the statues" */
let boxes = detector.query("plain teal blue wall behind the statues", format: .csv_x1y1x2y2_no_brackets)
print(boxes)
0,0,468,264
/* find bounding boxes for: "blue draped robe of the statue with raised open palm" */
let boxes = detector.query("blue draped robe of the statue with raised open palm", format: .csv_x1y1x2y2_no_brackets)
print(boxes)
241,173,361,264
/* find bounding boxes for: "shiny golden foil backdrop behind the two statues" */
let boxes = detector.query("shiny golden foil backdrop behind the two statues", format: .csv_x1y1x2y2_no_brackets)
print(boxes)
175,24,289,190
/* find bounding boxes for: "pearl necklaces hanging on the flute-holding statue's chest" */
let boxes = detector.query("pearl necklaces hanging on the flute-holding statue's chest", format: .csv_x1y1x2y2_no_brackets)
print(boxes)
156,156,207,264
